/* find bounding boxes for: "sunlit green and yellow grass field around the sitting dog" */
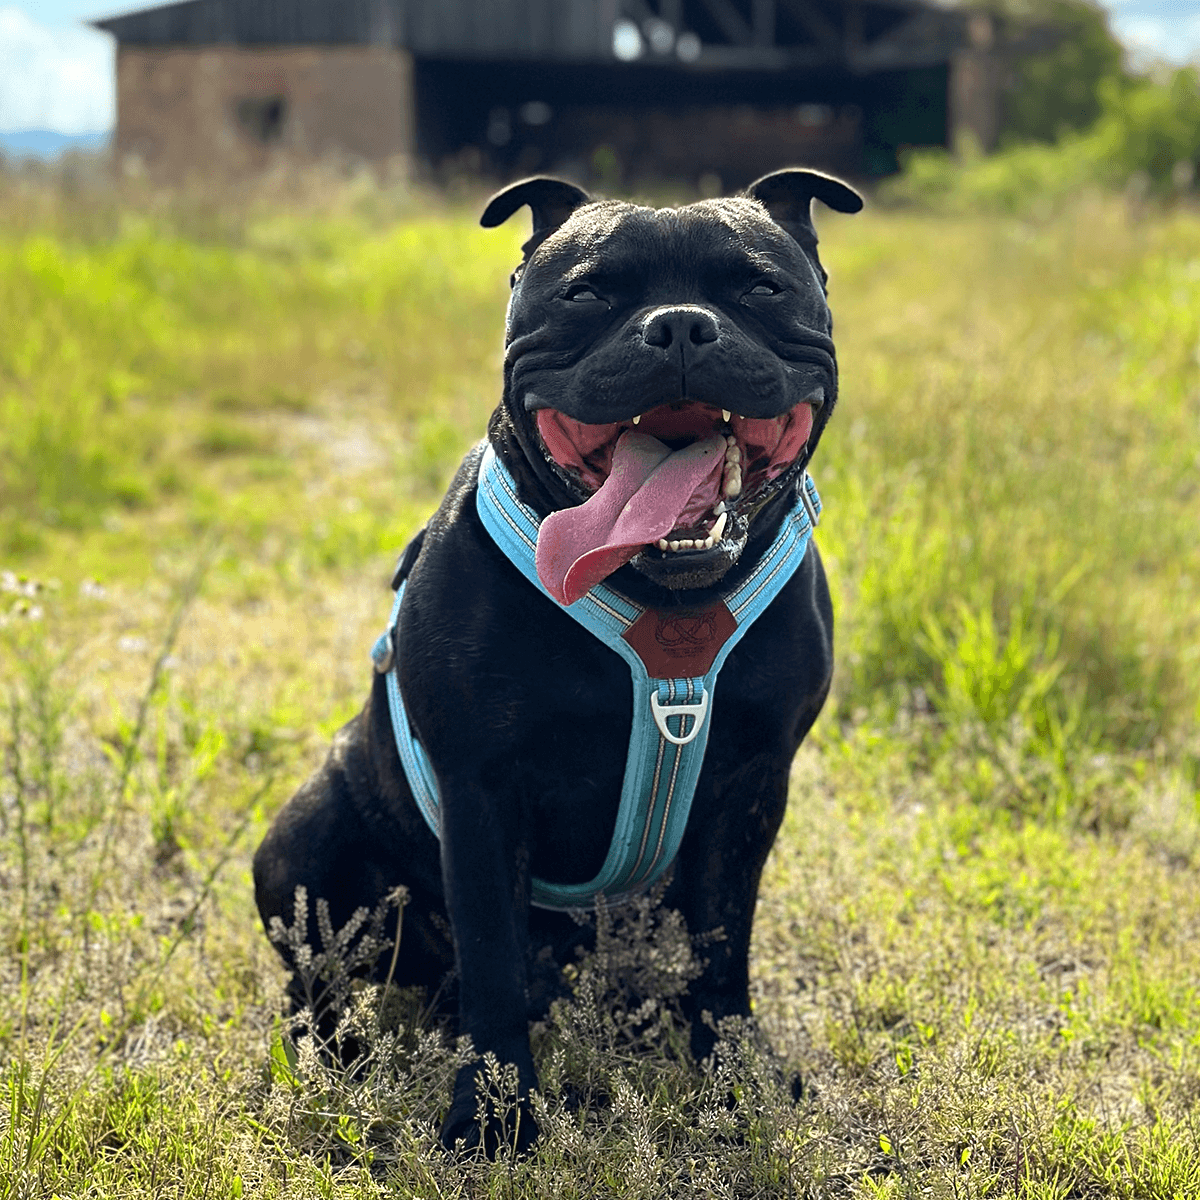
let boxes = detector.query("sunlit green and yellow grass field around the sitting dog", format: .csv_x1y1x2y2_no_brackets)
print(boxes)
0,180,1200,1200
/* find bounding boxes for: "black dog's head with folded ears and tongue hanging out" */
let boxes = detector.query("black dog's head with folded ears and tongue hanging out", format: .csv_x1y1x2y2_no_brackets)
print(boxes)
481,169,863,602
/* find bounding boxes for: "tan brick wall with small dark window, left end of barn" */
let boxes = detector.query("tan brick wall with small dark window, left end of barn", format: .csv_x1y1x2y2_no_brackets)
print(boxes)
116,46,413,184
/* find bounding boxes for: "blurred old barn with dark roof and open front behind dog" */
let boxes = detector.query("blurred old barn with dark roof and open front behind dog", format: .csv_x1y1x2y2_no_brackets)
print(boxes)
94,0,997,186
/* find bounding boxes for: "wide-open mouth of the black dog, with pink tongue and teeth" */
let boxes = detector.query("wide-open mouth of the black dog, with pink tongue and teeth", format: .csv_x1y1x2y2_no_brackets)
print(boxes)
536,396,821,604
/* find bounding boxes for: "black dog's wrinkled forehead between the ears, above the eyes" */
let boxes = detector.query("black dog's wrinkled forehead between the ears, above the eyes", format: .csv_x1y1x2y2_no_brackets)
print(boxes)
526,198,804,282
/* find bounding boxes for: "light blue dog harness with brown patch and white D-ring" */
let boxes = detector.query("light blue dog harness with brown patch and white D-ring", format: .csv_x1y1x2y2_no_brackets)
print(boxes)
371,446,821,911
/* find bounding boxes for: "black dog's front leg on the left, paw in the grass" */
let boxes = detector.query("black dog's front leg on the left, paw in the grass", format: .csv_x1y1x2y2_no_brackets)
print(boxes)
440,774,538,1157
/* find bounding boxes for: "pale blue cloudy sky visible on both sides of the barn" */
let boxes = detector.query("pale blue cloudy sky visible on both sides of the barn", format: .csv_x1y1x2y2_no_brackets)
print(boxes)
0,0,1200,133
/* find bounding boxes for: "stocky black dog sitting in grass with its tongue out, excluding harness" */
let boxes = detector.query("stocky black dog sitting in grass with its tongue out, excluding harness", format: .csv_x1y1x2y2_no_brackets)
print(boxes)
254,170,862,1147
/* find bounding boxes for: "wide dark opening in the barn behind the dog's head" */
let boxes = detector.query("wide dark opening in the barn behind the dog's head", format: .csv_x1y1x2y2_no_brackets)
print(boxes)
414,59,947,187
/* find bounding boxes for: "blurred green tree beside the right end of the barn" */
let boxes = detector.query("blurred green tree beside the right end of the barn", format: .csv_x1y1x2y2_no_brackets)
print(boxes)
988,0,1122,145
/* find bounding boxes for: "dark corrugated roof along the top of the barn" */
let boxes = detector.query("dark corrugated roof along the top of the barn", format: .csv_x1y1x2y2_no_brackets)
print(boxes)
92,0,961,70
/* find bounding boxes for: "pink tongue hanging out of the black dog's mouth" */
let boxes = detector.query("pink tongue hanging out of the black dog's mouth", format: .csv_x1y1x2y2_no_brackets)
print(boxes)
536,430,725,605
